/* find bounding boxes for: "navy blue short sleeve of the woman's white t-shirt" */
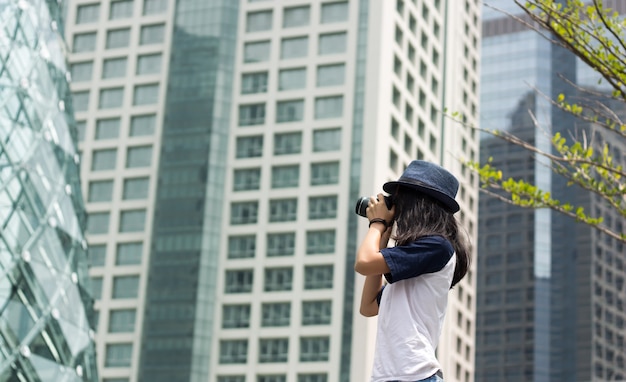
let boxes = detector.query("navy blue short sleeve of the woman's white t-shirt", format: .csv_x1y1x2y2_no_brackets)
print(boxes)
380,236,454,283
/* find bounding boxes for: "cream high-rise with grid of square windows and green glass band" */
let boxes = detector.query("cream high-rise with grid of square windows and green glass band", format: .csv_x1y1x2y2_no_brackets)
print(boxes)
67,0,480,382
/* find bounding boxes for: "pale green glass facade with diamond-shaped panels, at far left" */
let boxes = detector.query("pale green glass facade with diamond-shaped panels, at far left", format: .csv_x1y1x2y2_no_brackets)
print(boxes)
0,0,97,381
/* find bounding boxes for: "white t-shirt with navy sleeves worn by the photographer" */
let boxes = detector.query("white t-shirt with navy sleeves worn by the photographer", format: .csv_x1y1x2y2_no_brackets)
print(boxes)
371,236,456,382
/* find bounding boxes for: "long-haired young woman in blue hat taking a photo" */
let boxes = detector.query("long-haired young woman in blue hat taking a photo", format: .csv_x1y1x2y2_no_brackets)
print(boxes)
354,161,470,382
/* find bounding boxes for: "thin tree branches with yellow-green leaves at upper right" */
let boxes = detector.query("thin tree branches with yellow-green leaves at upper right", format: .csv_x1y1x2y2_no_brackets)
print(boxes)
466,0,626,242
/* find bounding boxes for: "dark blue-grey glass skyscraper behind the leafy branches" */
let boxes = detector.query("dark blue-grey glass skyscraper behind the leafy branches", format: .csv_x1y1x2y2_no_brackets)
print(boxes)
476,2,626,382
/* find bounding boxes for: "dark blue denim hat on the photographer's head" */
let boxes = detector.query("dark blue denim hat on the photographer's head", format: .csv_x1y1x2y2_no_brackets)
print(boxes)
383,160,460,213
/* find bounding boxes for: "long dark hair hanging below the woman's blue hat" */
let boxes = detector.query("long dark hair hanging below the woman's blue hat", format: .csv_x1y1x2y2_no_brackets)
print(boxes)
392,187,471,287
